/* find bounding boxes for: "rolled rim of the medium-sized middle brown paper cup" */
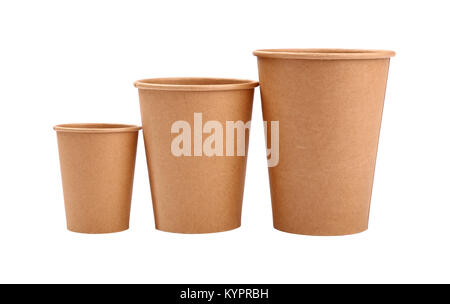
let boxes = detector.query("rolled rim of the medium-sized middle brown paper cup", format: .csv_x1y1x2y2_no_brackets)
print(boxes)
134,77,259,91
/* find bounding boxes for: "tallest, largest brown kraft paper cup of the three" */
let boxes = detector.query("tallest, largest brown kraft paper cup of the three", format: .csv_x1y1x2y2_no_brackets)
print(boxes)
254,49,394,235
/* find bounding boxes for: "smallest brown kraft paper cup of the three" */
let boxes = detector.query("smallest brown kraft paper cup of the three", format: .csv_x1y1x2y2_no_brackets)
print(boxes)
54,124,140,233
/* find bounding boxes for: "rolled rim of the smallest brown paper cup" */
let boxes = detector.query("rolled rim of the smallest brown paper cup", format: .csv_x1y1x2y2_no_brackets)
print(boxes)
53,123,142,133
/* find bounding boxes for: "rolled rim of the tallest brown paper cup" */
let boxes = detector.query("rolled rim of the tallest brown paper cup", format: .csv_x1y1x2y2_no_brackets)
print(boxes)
253,49,395,60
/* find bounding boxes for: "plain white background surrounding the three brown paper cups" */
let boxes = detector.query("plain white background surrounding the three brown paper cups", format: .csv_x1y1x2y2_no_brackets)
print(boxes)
0,0,450,283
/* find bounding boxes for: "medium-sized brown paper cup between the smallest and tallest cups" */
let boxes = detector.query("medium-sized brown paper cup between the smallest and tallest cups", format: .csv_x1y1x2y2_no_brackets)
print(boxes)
135,78,258,233
